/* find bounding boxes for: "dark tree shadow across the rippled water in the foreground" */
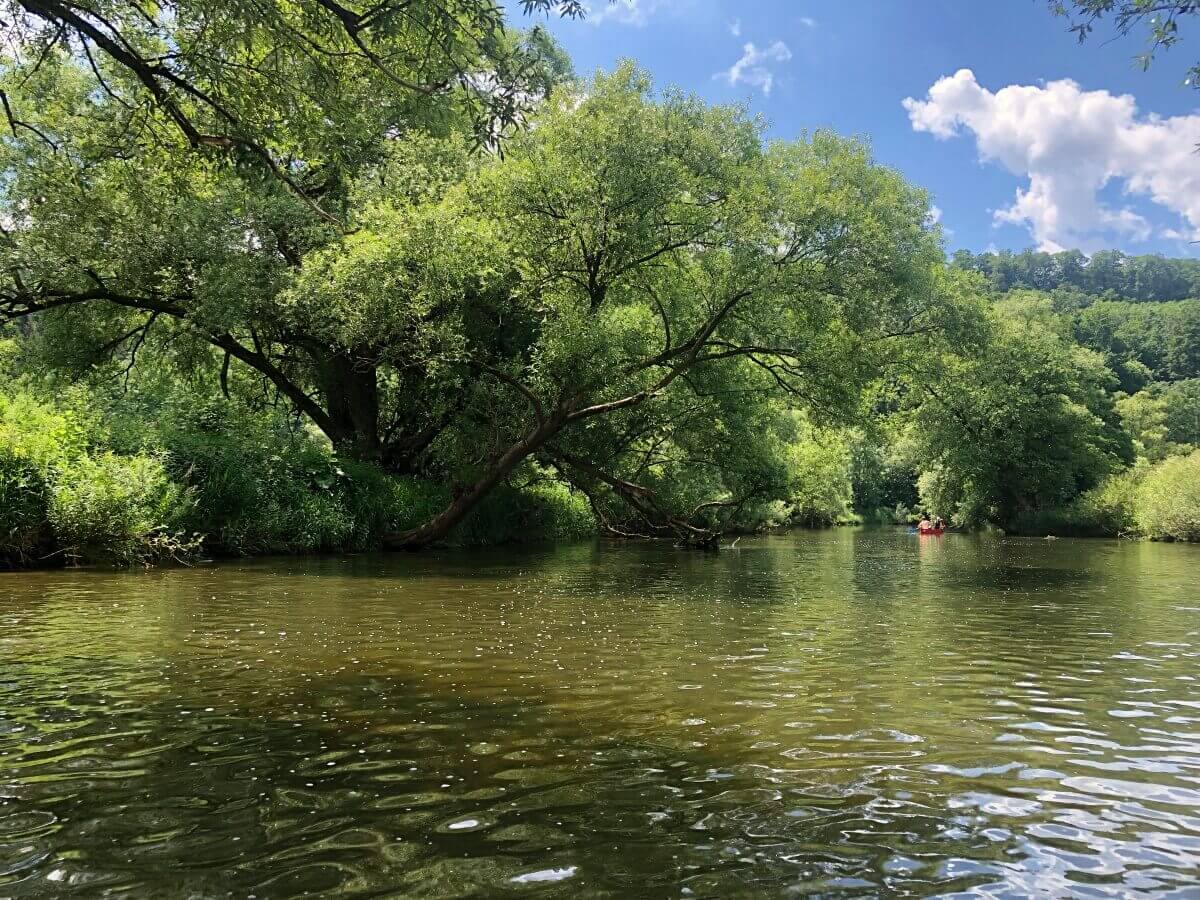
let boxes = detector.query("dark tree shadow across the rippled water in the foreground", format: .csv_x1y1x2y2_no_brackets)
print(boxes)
0,672,1060,896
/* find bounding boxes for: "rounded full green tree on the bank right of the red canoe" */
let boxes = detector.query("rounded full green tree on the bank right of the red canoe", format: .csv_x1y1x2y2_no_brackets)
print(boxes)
916,317,1133,526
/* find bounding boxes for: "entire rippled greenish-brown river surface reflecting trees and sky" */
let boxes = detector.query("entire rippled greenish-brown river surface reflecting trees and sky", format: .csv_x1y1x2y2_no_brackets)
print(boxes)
0,530,1200,898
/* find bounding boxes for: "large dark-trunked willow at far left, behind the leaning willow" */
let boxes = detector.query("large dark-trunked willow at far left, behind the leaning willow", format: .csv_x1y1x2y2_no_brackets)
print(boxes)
0,0,581,468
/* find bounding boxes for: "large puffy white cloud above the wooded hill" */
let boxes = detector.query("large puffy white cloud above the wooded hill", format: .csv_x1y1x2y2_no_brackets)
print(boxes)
904,68,1200,251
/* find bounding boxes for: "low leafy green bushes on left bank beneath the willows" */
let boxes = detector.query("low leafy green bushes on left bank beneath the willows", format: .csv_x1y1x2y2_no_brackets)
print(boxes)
0,394,594,568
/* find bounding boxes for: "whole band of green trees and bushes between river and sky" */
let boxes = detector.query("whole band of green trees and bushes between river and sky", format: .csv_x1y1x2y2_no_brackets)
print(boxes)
0,0,1200,568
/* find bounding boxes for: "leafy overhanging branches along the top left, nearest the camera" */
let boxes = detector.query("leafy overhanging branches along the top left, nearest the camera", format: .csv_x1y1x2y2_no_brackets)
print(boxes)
0,0,583,207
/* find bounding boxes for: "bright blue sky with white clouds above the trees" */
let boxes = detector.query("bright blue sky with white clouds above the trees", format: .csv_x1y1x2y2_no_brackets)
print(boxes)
532,0,1200,256
